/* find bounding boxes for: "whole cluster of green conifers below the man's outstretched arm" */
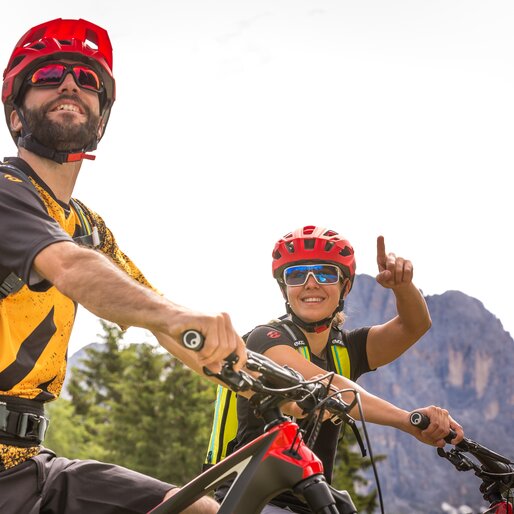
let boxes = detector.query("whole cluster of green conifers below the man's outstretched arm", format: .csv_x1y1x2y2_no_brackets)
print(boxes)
47,323,215,484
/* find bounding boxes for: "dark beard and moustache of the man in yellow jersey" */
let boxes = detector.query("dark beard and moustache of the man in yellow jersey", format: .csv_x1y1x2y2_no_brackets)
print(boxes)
23,95,100,152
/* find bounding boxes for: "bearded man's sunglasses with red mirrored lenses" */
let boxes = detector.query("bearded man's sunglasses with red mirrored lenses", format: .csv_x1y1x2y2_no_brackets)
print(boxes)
27,63,104,93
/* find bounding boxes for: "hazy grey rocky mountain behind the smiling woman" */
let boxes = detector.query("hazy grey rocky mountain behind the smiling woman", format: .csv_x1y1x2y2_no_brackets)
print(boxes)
345,275,514,514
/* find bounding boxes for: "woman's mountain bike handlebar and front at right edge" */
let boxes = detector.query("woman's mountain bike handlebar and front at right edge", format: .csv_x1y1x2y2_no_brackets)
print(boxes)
410,412,514,514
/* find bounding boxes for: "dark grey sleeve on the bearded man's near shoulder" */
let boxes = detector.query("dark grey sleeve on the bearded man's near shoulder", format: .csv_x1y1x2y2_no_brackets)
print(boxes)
0,172,73,284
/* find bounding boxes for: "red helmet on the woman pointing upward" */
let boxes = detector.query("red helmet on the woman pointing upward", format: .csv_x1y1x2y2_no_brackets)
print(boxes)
272,225,356,287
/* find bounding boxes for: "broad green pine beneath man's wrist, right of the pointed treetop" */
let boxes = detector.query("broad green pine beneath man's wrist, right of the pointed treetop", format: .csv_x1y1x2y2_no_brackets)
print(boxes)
101,338,215,484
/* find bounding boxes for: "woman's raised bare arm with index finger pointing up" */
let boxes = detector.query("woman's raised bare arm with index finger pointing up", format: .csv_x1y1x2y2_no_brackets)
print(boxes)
366,236,432,369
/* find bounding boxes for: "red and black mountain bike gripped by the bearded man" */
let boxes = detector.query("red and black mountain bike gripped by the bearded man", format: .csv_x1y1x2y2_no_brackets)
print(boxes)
146,331,367,514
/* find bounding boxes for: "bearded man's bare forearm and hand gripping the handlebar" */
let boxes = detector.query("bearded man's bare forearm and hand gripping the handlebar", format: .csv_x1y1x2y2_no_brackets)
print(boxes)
33,242,246,372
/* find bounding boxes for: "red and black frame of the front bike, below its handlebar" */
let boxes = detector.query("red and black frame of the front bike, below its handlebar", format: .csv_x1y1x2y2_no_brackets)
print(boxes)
149,418,357,514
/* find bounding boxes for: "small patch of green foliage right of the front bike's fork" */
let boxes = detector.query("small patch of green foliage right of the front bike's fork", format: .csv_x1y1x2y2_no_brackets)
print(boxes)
333,422,385,514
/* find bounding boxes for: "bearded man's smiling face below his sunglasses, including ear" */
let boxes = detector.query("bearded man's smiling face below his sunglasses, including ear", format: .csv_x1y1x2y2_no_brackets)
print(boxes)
12,61,100,151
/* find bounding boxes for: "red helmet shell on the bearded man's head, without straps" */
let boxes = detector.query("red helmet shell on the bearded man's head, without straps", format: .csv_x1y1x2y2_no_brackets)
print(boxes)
2,18,115,137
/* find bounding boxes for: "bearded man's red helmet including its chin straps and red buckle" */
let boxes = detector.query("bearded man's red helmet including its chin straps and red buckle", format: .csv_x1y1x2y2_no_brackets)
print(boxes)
2,18,116,164
